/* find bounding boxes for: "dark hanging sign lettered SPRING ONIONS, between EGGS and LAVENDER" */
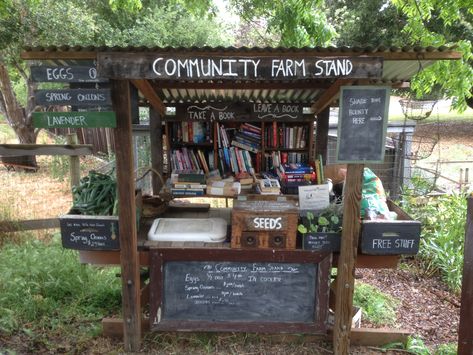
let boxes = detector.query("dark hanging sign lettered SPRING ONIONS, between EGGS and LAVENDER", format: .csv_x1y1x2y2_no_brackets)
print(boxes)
35,89,112,107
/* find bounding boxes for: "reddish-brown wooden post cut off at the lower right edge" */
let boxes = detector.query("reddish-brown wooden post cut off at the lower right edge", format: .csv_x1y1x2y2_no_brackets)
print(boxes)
458,195,473,355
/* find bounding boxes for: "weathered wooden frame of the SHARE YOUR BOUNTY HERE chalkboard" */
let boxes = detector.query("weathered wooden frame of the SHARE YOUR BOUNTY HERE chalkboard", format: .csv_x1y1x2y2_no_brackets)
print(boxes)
336,85,391,164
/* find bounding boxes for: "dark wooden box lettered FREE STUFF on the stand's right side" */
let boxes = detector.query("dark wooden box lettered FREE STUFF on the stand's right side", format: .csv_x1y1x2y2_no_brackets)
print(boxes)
360,200,421,255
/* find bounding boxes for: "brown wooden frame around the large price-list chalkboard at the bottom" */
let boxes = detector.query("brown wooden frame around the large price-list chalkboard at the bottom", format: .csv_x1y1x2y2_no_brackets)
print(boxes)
149,248,332,334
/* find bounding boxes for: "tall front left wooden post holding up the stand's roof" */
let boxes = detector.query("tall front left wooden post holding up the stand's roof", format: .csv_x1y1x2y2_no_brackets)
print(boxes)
111,80,141,352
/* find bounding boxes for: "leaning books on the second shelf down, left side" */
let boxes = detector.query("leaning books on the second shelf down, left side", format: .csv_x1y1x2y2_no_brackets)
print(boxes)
171,147,213,173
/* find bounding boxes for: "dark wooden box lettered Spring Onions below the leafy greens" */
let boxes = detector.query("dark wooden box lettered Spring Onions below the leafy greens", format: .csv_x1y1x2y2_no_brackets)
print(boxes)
59,191,142,250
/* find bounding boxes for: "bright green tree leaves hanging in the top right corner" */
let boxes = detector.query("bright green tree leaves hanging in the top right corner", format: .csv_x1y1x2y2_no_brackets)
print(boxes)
393,0,473,112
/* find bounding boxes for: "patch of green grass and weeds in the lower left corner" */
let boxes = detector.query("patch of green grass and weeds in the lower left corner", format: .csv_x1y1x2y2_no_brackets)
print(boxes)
0,237,121,336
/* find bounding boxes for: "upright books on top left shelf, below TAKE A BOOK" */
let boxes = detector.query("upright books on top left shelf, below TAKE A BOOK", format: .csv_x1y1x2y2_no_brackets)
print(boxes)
168,121,212,144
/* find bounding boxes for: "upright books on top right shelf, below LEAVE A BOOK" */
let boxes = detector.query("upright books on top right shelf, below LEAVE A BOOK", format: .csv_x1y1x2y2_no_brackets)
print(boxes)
264,122,308,149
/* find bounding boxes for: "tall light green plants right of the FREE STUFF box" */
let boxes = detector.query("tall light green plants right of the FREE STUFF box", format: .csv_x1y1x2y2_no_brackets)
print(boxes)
403,194,466,292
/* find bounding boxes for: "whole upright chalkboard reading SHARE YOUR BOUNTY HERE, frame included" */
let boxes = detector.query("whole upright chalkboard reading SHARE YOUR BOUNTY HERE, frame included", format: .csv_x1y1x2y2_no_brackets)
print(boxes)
337,86,390,163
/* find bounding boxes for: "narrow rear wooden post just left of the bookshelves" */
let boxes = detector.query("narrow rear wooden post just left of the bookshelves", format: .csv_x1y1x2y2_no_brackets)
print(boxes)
149,107,163,195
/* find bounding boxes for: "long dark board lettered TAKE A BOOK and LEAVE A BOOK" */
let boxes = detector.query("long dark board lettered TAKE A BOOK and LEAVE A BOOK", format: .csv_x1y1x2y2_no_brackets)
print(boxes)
173,102,306,122
